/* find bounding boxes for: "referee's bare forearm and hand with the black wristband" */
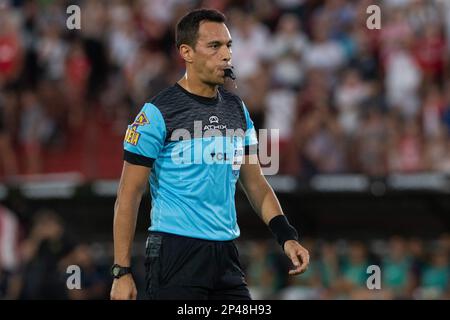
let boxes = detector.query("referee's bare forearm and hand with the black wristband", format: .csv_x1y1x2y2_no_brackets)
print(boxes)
239,154,309,275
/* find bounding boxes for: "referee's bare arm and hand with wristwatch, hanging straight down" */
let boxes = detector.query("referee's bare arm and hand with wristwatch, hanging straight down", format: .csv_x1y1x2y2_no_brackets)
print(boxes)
111,161,150,300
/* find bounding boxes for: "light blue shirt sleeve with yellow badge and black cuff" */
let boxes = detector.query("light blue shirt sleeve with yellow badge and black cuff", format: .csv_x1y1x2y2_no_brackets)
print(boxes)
123,103,166,167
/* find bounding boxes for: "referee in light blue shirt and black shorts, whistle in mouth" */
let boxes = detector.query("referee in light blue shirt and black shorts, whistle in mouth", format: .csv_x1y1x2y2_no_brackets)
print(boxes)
111,9,309,300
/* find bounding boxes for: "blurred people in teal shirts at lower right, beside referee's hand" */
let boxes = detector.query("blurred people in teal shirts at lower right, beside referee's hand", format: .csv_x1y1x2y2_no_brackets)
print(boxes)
241,234,450,300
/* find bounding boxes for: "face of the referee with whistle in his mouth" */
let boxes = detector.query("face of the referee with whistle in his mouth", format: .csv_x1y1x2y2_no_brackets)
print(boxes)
192,21,231,85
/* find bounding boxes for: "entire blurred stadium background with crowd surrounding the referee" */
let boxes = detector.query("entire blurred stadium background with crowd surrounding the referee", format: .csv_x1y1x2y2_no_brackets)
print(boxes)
0,0,450,299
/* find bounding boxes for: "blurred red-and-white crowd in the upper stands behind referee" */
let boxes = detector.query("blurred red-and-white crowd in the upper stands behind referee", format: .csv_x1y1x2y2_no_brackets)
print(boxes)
0,0,450,178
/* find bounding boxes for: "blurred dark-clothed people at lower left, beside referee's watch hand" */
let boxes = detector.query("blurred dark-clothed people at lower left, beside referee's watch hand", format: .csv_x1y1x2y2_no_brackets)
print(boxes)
0,205,112,300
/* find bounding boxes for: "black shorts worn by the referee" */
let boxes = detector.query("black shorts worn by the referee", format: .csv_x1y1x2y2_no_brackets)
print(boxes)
145,232,251,300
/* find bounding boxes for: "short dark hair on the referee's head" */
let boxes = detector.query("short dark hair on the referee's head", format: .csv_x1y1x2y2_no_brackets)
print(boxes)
175,9,226,48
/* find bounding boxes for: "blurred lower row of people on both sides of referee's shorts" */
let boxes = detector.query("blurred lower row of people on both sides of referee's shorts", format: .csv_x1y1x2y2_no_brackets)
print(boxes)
0,206,450,300
